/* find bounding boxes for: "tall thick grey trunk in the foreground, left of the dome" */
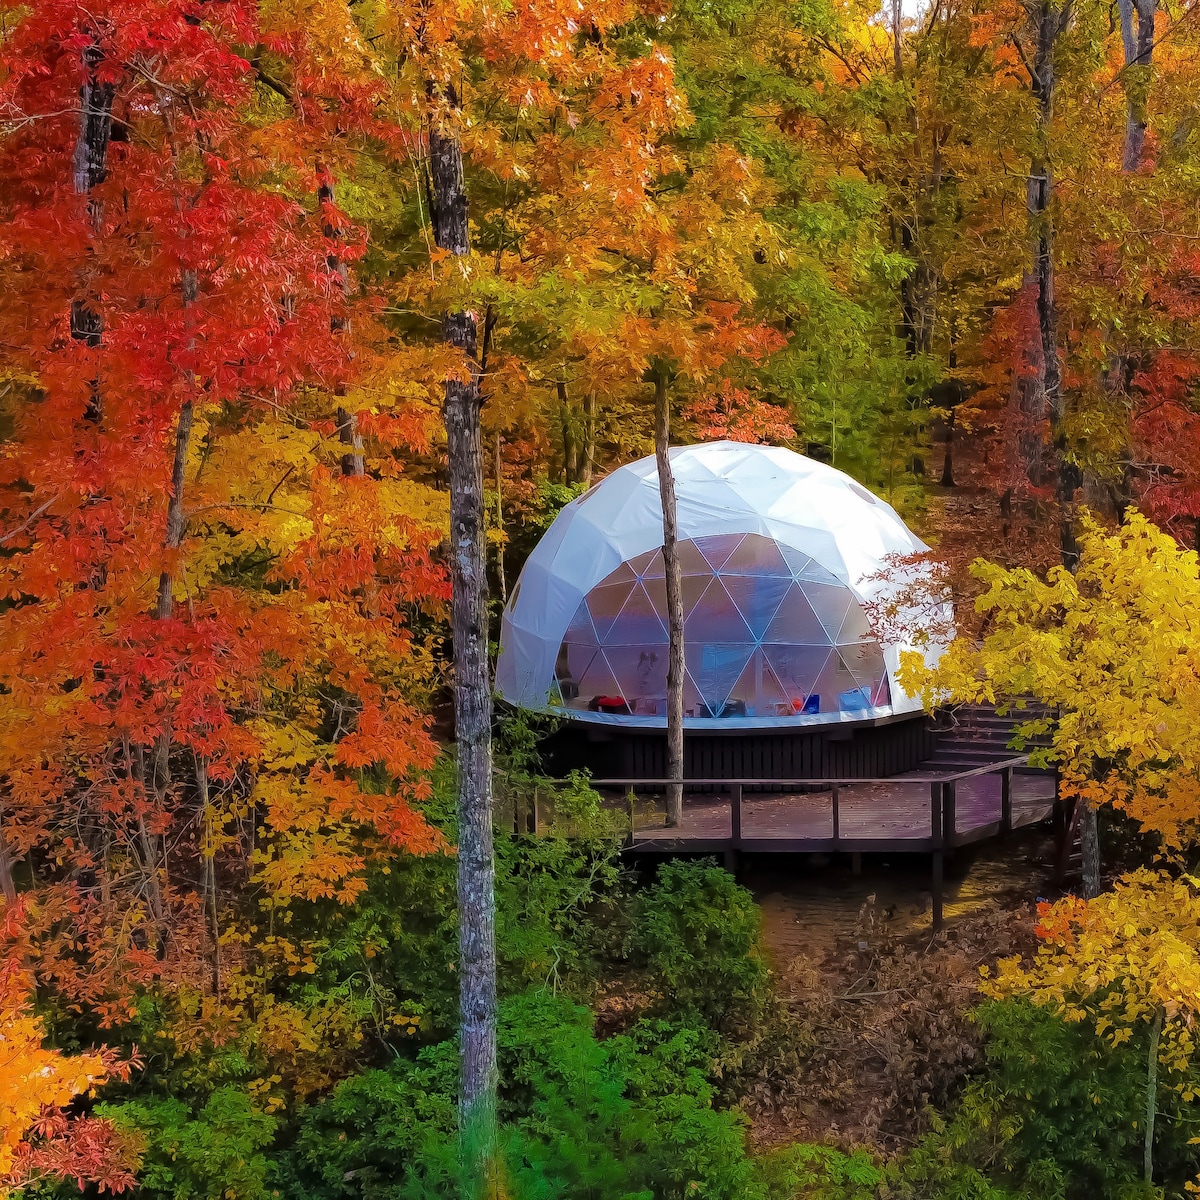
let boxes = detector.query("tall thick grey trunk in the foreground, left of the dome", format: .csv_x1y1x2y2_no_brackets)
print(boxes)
430,91,497,1196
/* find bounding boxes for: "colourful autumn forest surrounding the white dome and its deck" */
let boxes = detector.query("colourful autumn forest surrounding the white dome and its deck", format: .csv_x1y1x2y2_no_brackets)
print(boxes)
0,0,1200,1200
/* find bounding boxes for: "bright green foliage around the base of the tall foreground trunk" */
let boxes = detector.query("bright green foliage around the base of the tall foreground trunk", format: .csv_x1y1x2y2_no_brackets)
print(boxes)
278,989,766,1200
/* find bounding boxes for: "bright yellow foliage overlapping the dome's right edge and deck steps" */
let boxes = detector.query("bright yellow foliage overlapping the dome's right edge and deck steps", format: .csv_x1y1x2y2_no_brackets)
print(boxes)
900,511,1200,847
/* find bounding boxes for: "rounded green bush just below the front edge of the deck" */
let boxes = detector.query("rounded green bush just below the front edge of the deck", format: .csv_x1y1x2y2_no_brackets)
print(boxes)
634,862,768,1028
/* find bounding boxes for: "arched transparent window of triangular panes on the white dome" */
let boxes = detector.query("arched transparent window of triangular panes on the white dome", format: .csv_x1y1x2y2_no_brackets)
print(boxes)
551,534,892,718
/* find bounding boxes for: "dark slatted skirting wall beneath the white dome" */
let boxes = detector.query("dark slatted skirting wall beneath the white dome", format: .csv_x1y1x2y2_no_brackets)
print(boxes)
541,713,937,780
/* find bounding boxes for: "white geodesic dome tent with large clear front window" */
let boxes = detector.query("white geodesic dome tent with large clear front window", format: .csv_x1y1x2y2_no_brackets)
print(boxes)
496,442,928,730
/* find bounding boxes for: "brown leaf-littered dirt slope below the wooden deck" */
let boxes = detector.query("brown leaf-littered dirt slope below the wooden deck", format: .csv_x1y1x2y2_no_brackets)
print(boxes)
739,828,1057,1152
